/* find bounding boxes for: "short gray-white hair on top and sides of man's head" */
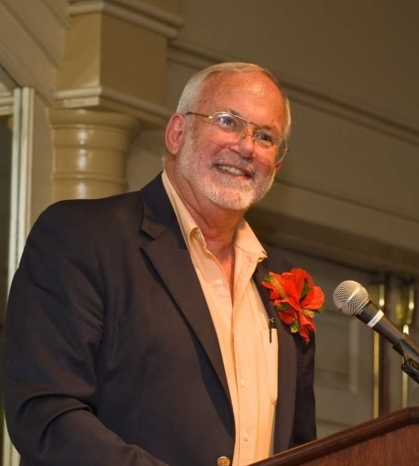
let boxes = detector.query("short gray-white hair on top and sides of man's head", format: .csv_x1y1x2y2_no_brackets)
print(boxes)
176,62,291,139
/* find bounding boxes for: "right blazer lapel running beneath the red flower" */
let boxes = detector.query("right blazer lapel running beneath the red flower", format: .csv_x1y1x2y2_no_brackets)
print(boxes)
254,261,297,453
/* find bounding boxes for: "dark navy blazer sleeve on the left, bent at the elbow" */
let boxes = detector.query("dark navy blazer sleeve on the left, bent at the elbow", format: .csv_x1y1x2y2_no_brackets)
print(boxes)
3,203,171,466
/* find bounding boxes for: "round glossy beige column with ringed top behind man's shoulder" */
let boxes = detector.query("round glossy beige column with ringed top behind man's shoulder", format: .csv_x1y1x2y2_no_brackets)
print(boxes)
50,109,140,201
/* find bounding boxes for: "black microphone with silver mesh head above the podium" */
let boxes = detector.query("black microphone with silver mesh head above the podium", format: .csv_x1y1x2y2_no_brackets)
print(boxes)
333,280,419,383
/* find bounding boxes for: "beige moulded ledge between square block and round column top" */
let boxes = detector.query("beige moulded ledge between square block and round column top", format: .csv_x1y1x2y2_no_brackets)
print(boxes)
54,86,172,125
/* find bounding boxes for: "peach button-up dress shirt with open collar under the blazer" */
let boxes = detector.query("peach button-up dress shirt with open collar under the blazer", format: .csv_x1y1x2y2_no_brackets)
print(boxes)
163,172,278,466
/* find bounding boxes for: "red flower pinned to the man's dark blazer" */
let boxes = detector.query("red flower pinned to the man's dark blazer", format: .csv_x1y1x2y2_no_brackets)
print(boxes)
262,268,324,344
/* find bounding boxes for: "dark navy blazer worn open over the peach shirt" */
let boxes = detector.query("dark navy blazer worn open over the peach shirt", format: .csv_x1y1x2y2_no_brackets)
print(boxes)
3,175,316,466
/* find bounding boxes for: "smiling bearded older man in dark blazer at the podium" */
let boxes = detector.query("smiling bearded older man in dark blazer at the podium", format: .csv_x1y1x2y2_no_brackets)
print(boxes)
3,63,316,466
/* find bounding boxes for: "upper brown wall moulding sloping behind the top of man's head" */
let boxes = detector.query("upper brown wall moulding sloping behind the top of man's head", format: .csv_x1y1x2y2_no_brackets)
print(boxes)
168,39,419,146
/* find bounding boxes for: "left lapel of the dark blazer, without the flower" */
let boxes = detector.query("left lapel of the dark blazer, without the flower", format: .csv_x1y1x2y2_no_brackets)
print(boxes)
141,178,230,400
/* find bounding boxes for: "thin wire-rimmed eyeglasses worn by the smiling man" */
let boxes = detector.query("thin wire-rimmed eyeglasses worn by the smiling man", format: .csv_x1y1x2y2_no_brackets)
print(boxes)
185,111,288,163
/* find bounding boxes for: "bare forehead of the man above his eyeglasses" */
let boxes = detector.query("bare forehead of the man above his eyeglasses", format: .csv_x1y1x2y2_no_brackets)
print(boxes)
198,72,285,129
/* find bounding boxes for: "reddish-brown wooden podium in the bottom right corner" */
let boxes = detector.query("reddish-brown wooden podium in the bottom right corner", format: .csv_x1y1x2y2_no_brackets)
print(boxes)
252,407,419,466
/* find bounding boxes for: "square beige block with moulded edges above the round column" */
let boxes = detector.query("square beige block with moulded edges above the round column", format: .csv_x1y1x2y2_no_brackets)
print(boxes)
55,0,182,127
